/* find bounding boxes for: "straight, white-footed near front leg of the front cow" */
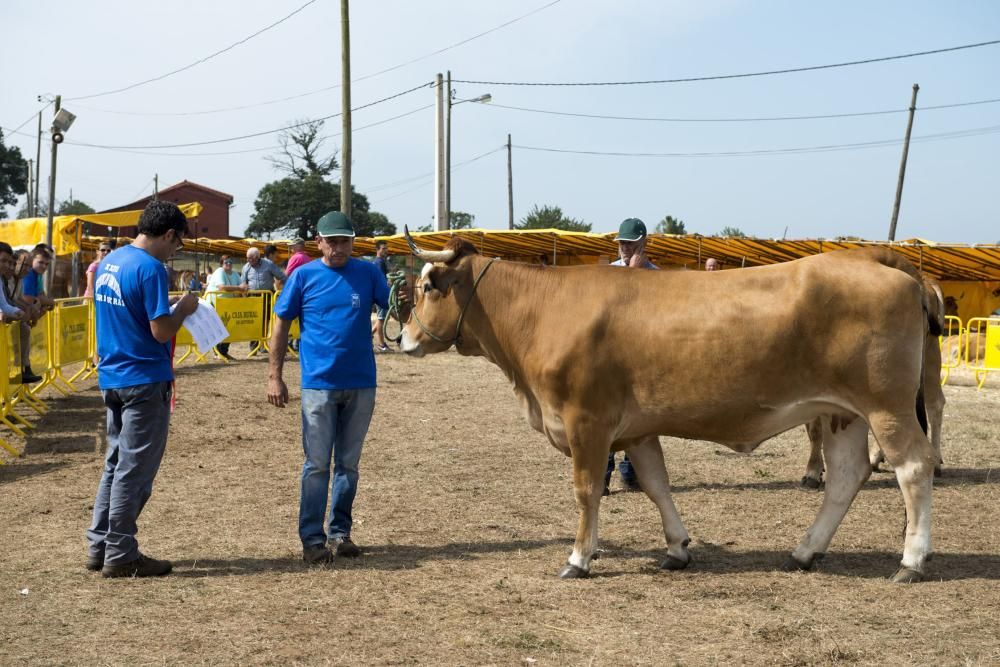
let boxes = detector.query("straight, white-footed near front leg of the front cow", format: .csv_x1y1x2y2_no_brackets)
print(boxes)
559,429,611,579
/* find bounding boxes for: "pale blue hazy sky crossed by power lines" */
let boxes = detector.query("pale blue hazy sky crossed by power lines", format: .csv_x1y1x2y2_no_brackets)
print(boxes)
0,0,1000,243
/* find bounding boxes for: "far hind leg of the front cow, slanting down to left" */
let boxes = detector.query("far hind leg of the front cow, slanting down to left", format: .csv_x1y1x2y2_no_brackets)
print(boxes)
783,417,871,571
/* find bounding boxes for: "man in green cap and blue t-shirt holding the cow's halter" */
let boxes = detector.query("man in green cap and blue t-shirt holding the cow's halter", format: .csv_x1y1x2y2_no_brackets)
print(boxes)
267,211,389,563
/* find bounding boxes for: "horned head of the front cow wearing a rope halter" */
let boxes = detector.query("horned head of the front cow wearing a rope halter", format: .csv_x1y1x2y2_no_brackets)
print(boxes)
399,230,488,357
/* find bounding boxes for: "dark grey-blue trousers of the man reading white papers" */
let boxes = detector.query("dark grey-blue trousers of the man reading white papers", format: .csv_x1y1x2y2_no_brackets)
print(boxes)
87,382,171,565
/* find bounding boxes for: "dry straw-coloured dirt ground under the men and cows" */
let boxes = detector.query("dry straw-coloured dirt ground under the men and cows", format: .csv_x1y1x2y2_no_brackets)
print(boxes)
0,353,1000,665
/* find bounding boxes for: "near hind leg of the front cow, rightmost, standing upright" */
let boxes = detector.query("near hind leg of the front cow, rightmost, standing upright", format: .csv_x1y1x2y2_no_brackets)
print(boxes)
870,411,937,583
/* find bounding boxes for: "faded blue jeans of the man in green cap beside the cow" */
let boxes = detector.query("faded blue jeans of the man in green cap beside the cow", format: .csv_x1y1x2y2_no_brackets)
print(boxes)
299,387,375,548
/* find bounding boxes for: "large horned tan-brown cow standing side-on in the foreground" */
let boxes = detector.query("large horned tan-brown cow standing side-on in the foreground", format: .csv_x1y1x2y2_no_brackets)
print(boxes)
401,234,935,582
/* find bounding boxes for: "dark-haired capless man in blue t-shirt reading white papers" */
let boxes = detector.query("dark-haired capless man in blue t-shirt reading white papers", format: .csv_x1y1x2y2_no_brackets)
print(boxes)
87,201,198,577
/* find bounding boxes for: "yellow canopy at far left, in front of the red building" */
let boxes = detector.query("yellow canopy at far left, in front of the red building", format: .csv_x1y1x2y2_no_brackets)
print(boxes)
0,202,202,255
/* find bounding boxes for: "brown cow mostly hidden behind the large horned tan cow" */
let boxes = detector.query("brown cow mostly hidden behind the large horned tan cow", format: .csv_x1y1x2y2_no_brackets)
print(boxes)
802,276,950,489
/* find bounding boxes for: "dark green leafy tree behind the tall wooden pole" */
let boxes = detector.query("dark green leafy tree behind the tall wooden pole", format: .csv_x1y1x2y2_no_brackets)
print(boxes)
247,175,396,238
